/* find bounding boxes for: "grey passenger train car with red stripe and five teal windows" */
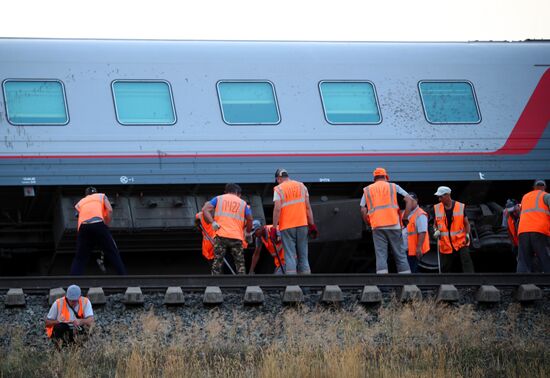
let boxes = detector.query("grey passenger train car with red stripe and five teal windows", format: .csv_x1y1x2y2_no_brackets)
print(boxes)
0,39,550,270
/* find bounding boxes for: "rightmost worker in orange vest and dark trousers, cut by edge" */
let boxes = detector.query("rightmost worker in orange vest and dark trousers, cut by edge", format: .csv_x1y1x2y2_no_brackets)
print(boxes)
517,180,550,273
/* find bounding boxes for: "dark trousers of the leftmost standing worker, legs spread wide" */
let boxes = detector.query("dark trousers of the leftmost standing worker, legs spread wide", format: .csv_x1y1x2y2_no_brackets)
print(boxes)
71,222,127,275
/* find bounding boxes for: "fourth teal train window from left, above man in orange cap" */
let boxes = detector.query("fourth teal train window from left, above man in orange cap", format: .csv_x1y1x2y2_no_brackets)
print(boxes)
319,81,382,125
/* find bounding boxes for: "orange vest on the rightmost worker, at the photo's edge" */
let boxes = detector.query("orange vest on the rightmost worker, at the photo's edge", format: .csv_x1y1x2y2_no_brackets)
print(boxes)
518,190,550,236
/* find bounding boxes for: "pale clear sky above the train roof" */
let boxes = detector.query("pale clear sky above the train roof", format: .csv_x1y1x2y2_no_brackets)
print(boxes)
0,0,550,41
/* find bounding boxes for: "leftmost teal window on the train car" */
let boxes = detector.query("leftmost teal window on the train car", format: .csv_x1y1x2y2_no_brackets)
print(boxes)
2,80,69,126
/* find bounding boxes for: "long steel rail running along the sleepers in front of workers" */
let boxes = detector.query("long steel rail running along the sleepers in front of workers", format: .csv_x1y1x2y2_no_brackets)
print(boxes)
0,273,550,292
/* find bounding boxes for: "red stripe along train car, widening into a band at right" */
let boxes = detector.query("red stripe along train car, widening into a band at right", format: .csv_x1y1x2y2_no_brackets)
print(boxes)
0,69,550,159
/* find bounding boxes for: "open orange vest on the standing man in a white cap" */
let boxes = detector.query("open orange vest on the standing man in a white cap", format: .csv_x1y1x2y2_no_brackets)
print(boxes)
434,201,468,254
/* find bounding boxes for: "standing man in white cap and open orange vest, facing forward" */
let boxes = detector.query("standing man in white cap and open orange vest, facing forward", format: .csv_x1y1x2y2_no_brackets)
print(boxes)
434,186,474,273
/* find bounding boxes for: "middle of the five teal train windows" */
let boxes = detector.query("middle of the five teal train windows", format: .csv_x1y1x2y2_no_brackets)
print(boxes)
217,81,281,125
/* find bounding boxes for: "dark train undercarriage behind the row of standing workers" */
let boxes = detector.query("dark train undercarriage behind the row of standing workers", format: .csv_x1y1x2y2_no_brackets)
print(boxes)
0,181,532,276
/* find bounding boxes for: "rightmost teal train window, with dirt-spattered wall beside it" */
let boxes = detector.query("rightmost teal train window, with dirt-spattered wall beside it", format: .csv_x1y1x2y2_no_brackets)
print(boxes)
418,81,481,124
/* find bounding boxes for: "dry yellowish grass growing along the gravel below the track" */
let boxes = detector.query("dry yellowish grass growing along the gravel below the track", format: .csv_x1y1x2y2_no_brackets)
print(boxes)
0,301,550,378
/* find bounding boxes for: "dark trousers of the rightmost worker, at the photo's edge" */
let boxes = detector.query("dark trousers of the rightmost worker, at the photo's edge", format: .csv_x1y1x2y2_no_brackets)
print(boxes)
517,232,550,273
